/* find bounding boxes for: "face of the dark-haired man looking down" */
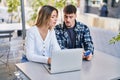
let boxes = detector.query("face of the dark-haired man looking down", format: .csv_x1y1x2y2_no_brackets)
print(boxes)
64,13,76,27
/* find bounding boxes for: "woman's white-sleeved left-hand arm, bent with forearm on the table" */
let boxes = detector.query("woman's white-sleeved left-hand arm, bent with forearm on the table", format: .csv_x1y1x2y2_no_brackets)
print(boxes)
26,31,48,63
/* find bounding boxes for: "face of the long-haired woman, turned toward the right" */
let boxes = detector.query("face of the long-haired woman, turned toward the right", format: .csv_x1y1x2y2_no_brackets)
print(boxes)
49,10,58,28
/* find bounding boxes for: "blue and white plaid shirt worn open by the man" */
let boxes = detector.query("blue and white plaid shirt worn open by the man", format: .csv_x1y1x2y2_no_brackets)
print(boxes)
55,21,94,53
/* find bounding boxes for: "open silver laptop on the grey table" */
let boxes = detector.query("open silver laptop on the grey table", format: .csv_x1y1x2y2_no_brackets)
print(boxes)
43,48,83,74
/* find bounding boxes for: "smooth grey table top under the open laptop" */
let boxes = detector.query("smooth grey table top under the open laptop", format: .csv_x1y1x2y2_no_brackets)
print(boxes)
16,51,120,80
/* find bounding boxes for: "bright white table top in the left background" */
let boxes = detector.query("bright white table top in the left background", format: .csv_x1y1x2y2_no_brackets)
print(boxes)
0,23,30,31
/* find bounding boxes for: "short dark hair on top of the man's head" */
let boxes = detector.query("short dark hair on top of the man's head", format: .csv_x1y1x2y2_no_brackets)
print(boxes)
63,4,77,14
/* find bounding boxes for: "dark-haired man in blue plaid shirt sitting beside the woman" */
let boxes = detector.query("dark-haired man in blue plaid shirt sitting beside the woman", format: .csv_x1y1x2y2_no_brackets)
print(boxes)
55,5,94,60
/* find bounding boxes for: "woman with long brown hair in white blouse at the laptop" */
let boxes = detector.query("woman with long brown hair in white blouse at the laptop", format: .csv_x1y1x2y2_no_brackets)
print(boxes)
26,5,60,64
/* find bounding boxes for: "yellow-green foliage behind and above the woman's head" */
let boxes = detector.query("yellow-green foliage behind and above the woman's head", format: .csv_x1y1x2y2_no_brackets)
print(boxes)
28,0,75,25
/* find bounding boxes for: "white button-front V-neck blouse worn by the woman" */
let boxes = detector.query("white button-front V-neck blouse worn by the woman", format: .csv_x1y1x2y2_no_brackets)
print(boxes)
26,26,60,63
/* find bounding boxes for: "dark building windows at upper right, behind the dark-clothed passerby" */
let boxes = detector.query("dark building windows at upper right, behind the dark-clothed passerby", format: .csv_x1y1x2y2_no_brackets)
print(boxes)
85,0,120,18
